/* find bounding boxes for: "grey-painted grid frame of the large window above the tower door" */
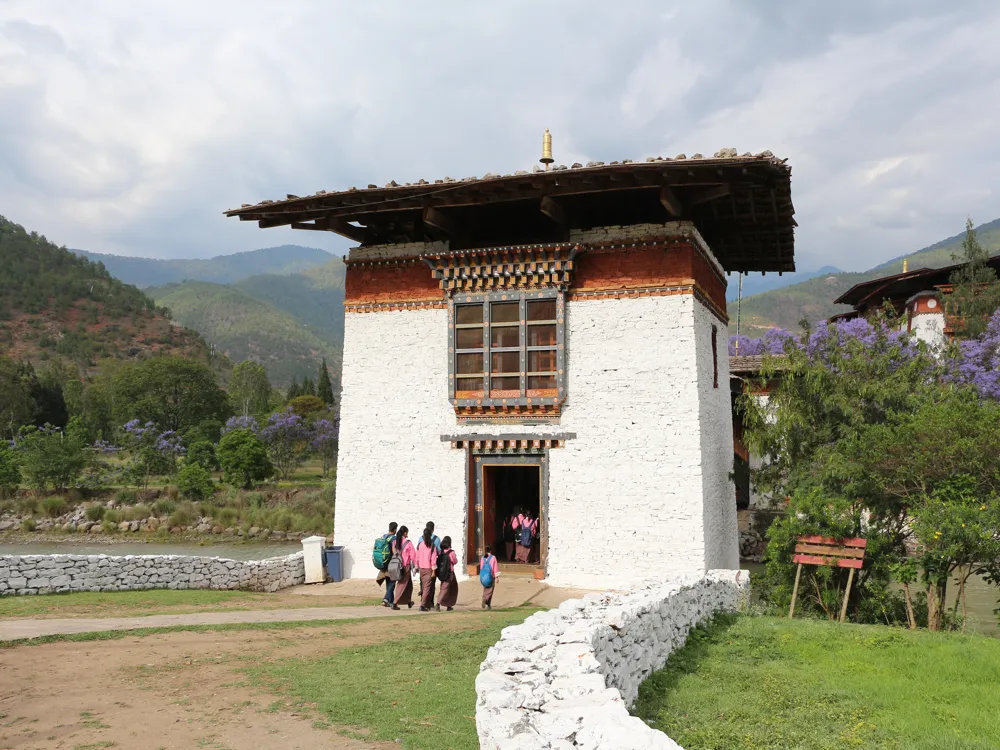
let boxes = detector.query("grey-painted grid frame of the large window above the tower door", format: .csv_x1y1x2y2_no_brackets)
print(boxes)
448,289,566,407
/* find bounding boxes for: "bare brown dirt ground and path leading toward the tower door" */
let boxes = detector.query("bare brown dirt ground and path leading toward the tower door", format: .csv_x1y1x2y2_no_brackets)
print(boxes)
0,608,482,750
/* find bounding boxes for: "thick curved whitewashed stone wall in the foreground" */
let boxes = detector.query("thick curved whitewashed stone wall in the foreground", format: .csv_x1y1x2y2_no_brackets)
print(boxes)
476,570,750,750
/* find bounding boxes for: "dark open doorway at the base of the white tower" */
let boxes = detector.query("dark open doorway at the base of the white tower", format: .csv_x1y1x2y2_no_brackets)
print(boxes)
483,464,542,564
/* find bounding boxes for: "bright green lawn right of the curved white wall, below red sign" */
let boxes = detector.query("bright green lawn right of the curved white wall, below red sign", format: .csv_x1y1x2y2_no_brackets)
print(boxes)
633,617,1000,750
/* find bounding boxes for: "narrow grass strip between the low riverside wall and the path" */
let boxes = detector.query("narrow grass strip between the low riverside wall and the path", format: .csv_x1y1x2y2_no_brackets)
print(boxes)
0,589,378,618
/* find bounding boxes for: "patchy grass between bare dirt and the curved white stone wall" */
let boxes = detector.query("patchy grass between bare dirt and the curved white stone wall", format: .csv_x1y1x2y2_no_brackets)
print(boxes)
240,609,534,750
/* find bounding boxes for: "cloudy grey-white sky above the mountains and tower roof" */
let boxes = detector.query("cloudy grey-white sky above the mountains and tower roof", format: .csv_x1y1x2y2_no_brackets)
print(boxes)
0,0,1000,270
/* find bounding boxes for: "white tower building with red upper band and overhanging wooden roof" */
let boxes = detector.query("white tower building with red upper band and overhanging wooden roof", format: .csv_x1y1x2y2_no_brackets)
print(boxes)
227,150,794,586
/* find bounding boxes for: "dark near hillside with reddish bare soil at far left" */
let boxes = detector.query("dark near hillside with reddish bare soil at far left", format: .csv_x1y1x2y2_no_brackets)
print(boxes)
0,216,221,372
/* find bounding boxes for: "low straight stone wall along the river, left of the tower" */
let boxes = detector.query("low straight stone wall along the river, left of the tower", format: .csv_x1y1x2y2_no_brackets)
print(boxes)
0,552,305,596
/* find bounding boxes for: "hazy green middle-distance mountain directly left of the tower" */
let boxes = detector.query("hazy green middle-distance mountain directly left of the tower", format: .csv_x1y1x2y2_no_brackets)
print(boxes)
147,280,344,387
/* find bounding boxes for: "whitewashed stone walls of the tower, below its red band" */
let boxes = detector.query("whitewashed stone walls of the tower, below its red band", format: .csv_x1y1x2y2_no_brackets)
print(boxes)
335,295,737,588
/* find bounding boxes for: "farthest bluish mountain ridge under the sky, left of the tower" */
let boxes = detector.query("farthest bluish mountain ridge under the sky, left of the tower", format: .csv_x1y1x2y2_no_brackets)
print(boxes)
73,245,334,288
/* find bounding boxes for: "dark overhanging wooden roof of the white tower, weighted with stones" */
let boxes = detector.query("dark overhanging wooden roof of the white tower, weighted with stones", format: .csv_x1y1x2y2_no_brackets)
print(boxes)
225,149,796,272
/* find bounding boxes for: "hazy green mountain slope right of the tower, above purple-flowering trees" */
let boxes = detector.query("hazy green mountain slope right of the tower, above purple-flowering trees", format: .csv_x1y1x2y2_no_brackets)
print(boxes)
729,219,1000,336
